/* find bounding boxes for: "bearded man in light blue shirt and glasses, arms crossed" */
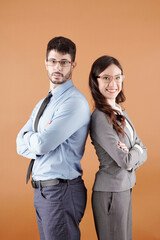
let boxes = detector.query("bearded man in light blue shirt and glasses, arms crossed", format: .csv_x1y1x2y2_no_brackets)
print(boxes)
17,37,90,240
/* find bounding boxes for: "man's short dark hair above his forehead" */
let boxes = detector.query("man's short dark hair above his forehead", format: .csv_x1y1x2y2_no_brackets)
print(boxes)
46,37,76,62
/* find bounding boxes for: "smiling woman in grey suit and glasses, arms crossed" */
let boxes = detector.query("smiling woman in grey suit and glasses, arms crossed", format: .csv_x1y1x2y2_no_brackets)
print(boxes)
89,56,147,240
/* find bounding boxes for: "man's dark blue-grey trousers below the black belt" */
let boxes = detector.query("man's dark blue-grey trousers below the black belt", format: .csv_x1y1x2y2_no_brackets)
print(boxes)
34,177,87,240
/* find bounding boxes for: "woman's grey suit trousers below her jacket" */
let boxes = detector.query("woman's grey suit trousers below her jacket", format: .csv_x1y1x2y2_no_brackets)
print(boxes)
92,189,132,240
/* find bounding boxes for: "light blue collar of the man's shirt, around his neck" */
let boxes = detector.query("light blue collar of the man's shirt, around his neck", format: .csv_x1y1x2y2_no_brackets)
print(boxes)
52,79,73,99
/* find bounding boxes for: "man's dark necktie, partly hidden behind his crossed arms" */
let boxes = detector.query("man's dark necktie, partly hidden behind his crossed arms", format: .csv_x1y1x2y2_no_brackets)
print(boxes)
26,93,52,183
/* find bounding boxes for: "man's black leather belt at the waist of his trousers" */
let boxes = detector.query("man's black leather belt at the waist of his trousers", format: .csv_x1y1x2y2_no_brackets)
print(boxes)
31,179,69,188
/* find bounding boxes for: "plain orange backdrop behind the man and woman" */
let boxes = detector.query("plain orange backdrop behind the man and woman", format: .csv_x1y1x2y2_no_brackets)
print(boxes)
0,0,160,240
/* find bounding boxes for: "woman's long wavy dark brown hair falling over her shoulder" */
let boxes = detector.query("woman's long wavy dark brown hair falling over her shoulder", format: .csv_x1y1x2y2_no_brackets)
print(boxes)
89,56,126,136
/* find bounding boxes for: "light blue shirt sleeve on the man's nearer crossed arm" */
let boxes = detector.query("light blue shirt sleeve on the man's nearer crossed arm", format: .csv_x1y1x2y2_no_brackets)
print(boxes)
21,99,89,155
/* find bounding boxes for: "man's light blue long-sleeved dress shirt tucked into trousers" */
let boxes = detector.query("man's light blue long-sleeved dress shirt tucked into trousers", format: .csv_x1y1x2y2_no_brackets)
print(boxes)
17,80,90,181
